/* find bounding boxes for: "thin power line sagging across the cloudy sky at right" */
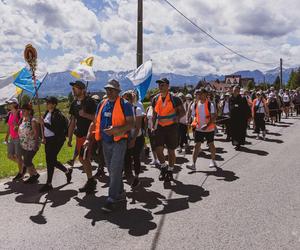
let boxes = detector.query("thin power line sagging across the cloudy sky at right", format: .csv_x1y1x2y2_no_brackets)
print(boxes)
163,0,277,65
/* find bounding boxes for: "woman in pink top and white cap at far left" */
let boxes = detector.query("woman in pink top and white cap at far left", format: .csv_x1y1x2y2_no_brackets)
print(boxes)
5,98,26,180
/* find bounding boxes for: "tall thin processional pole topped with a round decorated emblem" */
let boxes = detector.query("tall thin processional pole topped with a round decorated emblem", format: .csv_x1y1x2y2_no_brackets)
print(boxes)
24,44,44,140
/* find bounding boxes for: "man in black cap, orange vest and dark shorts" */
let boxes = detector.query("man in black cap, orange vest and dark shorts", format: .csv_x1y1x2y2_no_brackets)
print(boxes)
152,78,185,181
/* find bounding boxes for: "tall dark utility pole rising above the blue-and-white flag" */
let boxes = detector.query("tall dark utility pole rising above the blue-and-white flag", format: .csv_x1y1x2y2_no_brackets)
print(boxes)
136,0,143,68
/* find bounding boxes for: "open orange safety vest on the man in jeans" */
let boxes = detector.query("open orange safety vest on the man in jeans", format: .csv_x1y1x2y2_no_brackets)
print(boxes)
95,97,128,142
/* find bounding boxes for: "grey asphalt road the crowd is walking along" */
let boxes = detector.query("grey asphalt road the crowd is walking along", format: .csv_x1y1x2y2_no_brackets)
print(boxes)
0,117,300,249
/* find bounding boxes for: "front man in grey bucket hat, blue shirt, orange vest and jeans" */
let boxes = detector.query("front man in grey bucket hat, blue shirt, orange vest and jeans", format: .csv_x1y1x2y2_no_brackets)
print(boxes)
84,80,134,212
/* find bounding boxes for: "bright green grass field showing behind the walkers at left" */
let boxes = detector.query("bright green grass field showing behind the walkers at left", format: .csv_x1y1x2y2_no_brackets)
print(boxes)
0,99,149,178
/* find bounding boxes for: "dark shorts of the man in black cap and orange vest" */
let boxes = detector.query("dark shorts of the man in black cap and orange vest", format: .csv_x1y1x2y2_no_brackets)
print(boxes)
155,124,179,150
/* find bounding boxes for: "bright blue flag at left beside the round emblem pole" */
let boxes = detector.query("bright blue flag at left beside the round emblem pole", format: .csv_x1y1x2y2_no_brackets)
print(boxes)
14,68,41,96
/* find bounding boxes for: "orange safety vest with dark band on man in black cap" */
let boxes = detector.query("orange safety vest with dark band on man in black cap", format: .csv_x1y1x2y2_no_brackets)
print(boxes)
154,93,177,127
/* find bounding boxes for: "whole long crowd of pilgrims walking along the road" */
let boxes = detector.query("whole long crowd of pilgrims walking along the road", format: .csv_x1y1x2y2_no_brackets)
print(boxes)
5,78,300,212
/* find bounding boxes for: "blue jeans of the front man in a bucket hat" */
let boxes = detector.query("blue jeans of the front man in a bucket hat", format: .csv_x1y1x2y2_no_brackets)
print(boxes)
102,139,127,201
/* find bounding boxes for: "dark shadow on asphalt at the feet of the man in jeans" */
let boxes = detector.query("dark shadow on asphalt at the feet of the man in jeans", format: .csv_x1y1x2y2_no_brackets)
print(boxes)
74,195,157,236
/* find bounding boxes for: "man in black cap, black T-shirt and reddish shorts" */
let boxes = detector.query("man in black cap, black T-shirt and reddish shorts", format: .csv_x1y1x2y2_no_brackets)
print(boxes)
68,81,97,193
